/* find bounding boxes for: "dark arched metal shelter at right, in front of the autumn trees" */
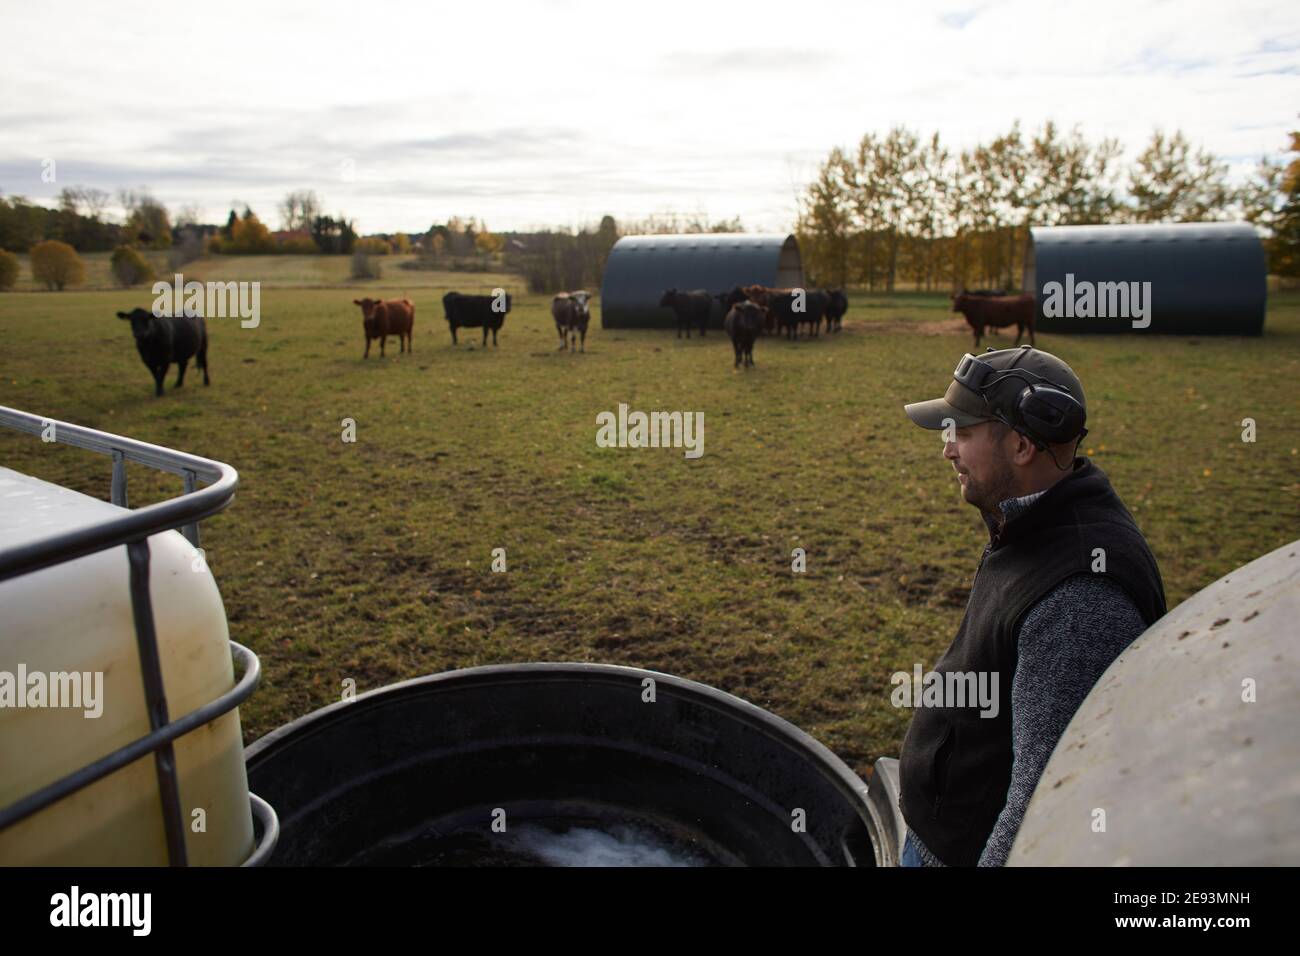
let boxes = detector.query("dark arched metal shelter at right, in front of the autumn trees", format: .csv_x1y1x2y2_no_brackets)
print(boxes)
1024,222,1268,336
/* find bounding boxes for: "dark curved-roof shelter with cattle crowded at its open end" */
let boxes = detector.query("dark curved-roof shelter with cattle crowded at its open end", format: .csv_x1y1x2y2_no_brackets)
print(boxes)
601,233,803,329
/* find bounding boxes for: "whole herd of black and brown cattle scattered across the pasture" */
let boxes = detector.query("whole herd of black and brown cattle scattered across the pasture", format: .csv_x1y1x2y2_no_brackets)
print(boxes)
117,278,1036,395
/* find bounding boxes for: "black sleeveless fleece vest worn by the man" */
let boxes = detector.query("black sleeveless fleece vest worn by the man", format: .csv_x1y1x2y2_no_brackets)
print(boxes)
898,457,1165,866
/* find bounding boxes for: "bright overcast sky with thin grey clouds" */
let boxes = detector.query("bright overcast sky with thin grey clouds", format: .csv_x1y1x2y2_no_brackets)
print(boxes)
0,0,1300,233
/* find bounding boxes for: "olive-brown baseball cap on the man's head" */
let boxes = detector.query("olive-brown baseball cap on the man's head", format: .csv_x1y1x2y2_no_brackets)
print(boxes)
902,345,1088,428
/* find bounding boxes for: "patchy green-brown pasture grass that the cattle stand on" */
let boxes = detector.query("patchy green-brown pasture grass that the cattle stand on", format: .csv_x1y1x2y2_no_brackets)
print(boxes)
0,283,1300,774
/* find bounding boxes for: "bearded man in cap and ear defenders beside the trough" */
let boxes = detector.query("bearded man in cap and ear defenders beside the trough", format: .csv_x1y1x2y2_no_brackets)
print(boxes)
898,345,1165,866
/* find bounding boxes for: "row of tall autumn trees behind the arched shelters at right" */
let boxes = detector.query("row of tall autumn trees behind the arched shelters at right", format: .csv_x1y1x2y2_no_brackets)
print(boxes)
796,122,1300,291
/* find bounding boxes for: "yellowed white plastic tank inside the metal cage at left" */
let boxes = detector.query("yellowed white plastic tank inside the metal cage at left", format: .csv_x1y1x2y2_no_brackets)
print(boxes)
0,467,254,866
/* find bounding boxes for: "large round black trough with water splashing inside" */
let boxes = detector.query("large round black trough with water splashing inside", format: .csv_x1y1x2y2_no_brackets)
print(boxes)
247,663,888,866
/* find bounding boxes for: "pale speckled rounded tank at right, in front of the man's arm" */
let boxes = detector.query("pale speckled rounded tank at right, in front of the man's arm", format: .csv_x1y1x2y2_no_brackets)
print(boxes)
1008,540,1300,866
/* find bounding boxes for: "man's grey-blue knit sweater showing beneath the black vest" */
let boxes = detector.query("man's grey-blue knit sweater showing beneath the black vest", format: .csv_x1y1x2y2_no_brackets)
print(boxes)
907,492,1147,866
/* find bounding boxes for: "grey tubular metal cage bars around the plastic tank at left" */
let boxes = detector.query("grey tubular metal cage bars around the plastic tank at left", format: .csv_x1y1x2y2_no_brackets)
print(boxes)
0,406,280,866
